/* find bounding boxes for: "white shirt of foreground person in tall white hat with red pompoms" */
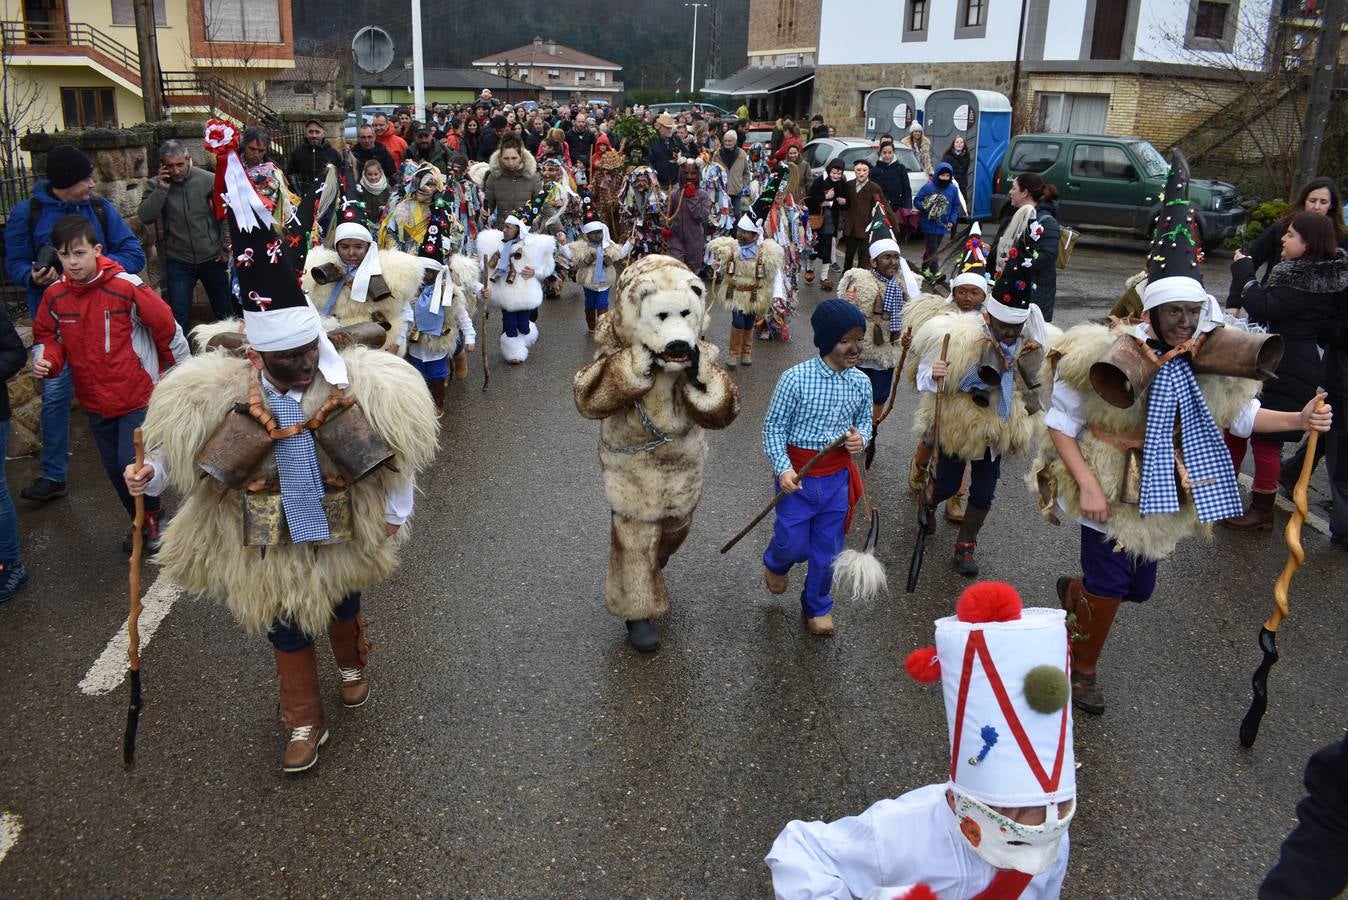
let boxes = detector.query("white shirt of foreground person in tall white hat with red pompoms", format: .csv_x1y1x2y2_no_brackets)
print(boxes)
764,784,1070,900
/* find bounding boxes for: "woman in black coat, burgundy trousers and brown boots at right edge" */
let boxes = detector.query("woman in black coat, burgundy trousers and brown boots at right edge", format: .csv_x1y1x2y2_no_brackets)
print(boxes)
1221,212,1348,531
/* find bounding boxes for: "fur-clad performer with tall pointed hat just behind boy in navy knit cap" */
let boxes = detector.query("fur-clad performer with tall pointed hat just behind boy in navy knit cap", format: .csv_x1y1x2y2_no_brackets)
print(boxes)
838,207,918,418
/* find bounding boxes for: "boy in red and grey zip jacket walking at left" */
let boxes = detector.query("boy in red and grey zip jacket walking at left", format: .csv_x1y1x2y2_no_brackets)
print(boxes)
32,216,190,552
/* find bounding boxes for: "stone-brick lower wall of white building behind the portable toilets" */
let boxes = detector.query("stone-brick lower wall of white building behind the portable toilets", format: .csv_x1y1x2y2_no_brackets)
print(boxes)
814,62,1012,137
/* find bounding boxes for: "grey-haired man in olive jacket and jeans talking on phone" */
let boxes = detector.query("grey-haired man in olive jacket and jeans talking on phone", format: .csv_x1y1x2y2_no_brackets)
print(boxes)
136,140,233,334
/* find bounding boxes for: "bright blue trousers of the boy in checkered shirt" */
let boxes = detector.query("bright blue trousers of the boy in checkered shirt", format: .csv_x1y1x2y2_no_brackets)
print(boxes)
763,469,848,618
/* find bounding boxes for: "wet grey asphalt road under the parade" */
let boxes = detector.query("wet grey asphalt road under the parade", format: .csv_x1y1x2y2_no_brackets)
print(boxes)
0,240,1348,897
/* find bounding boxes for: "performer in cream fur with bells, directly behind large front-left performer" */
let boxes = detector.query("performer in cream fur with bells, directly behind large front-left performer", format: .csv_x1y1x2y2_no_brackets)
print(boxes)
301,210,425,356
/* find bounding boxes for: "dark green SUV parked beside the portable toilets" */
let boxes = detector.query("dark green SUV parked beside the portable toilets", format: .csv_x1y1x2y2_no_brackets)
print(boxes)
992,133,1246,249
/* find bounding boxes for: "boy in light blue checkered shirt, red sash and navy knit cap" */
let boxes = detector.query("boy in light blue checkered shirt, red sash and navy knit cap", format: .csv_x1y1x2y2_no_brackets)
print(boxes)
763,299,871,635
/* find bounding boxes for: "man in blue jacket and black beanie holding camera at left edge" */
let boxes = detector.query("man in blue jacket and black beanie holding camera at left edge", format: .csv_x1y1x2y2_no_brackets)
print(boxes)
4,144,146,503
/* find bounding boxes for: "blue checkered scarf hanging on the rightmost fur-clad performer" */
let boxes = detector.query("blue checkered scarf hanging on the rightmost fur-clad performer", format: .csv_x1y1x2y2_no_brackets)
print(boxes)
1138,357,1244,521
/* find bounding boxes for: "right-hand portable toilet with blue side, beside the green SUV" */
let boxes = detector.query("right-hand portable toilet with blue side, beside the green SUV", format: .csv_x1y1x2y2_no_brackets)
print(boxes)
922,88,1011,218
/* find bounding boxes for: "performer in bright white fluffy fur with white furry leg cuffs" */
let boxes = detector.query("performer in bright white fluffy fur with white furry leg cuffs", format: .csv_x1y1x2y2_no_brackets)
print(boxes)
477,194,557,365
